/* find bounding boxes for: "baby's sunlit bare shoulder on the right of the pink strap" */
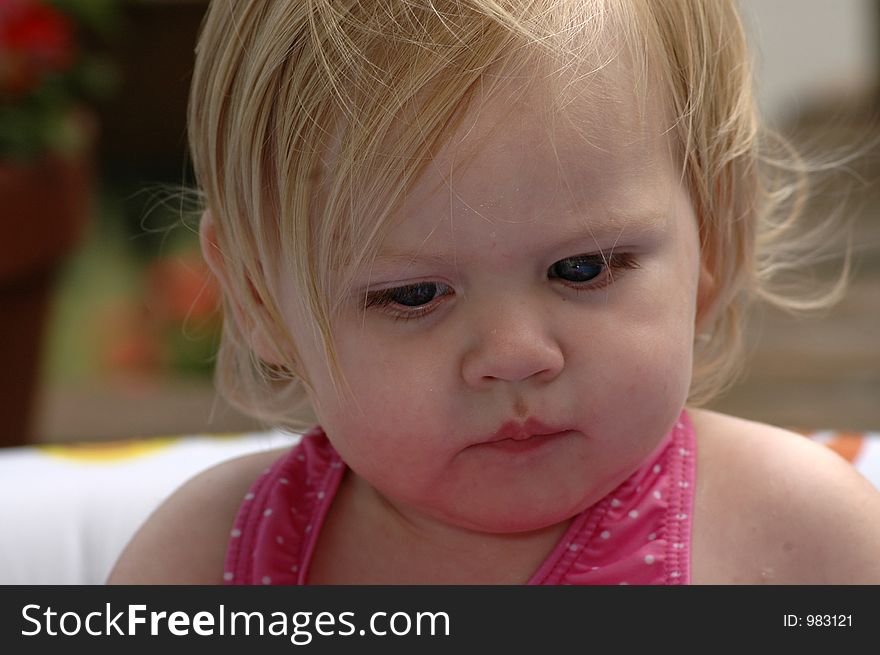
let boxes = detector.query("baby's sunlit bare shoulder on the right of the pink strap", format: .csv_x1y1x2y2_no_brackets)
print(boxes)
690,410,880,584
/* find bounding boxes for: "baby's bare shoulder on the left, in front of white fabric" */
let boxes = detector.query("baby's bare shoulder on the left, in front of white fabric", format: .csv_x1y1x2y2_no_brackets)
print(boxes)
107,449,286,584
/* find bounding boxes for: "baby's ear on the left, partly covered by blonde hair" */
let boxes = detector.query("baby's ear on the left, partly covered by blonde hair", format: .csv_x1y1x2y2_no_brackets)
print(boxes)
199,209,283,366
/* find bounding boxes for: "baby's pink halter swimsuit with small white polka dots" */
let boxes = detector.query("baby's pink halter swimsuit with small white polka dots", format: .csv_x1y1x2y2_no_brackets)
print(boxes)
224,412,696,585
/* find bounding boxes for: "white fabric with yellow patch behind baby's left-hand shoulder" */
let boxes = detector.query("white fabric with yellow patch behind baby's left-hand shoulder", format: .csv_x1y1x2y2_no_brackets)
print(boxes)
0,432,298,584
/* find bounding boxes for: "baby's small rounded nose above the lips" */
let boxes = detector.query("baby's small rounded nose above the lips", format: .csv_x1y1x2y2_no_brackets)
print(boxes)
461,308,565,389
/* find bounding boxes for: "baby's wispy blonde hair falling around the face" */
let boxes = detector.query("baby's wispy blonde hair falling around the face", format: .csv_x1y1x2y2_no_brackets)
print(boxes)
189,0,833,428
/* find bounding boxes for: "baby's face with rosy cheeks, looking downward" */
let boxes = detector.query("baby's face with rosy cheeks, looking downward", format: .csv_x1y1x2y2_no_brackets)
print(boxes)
276,70,700,532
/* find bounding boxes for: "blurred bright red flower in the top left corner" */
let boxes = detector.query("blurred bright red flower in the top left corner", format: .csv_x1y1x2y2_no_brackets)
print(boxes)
0,0,74,95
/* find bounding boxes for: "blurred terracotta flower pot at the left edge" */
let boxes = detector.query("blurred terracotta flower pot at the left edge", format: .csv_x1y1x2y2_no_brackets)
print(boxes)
0,143,93,446
